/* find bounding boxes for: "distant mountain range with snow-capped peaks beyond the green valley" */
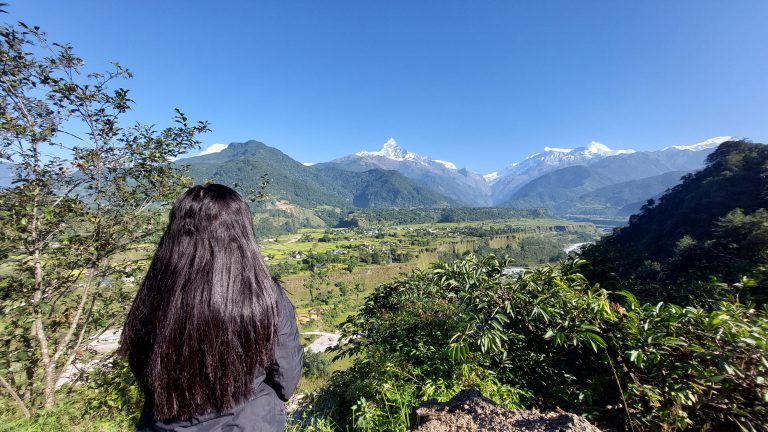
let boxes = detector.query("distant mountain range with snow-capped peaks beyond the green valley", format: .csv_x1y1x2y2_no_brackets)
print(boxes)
176,137,733,218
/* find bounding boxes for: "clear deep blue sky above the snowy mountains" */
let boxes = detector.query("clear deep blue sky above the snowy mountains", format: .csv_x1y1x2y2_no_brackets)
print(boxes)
7,0,768,173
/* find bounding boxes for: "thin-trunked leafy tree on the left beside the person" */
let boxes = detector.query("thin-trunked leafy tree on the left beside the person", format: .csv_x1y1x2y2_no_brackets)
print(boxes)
0,19,208,416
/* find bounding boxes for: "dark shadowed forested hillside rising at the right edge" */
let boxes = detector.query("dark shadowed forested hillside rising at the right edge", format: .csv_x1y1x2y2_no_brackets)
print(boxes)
582,141,768,304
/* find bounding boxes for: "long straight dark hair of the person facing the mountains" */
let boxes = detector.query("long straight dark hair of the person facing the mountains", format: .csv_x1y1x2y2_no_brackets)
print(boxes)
121,184,278,419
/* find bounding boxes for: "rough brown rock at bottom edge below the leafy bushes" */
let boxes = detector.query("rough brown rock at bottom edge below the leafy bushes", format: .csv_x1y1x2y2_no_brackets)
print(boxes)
412,389,600,432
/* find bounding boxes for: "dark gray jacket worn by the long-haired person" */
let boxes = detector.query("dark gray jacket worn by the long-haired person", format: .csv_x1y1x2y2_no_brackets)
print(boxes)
136,288,304,432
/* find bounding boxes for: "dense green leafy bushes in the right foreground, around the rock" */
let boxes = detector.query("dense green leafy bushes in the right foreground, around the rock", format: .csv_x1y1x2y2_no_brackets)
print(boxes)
308,255,768,430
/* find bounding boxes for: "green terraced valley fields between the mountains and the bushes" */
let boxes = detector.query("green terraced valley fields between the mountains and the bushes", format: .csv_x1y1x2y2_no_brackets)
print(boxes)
261,219,599,314
